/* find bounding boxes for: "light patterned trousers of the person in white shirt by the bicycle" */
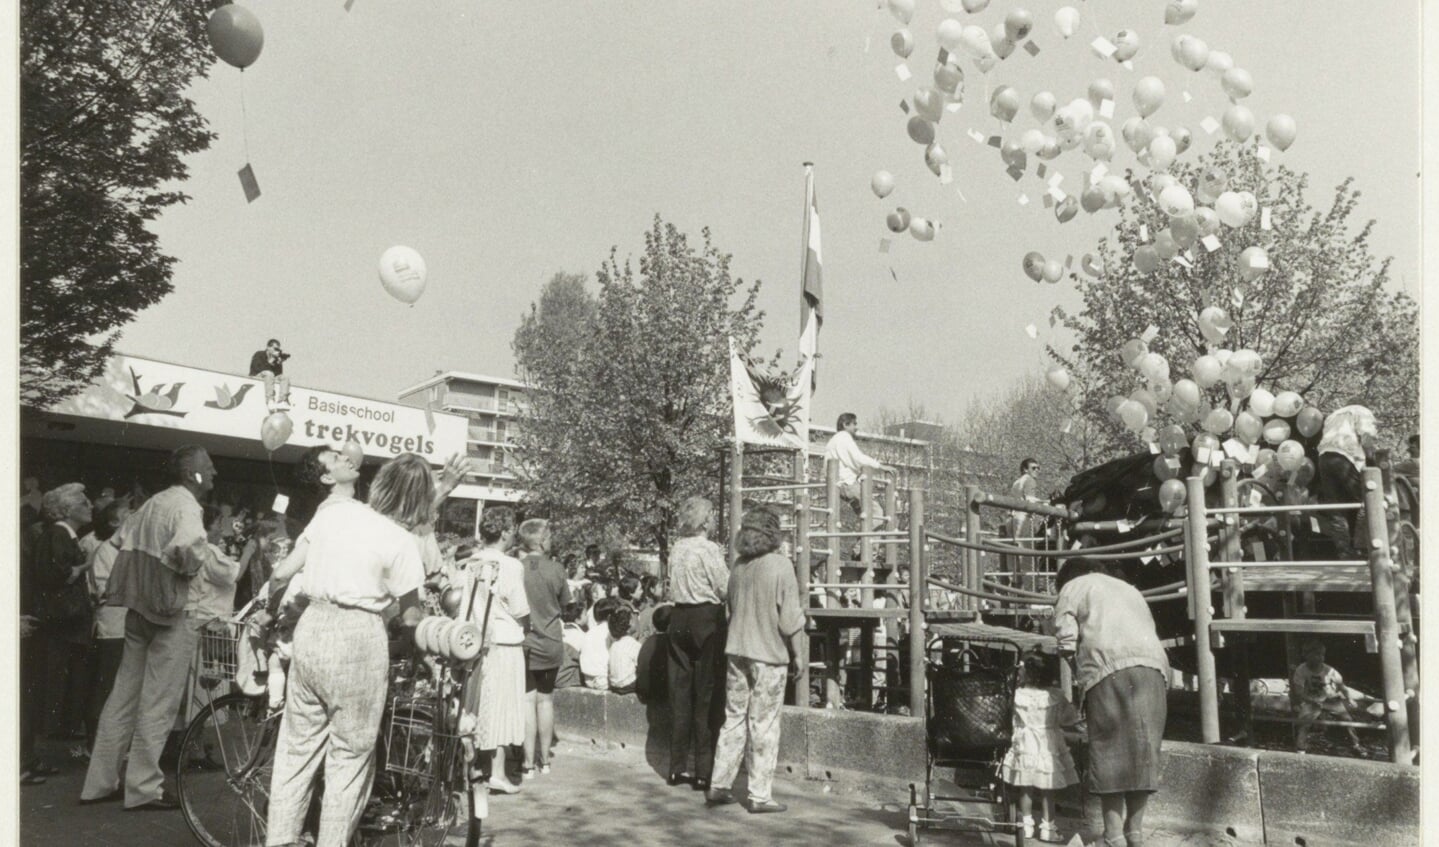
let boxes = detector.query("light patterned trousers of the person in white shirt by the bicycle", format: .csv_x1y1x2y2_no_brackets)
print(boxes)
265,603,390,847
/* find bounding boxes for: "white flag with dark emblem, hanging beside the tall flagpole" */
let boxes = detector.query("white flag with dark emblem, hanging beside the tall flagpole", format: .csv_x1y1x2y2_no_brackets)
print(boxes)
730,338,814,450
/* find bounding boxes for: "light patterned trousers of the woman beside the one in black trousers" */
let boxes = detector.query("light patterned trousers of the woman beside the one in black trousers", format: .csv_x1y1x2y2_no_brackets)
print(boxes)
709,656,786,802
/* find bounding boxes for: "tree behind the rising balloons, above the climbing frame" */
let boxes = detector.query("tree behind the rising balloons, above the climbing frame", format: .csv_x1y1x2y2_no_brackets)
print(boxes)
1049,142,1419,449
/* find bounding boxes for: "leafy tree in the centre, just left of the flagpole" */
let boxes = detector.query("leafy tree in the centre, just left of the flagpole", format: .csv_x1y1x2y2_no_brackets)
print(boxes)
514,216,764,561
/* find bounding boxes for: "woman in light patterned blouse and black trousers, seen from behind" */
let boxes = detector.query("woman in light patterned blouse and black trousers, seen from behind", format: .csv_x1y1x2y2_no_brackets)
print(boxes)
668,498,730,791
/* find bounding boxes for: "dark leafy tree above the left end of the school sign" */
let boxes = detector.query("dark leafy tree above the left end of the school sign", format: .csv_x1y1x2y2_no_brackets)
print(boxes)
20,0,214,407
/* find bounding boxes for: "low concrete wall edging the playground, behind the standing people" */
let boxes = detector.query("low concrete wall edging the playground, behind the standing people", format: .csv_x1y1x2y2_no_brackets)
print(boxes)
554,689,1420,847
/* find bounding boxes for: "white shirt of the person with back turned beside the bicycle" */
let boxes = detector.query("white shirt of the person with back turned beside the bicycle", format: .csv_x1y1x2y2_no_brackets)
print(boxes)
299,498,425,614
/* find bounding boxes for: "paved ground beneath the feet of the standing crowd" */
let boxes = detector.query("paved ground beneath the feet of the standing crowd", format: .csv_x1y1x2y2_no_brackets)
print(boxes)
19,742,1237,847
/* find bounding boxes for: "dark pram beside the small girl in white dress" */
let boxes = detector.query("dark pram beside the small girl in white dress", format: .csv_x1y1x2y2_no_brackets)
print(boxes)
909,615,1059,847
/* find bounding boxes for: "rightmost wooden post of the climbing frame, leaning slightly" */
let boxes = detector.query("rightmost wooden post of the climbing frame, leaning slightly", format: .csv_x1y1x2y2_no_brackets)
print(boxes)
1364,467,1412,765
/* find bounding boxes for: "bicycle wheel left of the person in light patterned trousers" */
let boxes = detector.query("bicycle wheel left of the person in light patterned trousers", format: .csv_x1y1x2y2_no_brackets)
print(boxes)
176,695,279,847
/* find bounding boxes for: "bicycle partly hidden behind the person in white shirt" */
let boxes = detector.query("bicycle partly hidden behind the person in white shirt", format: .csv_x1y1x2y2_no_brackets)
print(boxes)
176,613,485,847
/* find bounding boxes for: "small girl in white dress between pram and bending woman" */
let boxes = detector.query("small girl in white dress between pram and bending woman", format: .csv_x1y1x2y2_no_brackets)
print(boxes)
1000,653,1079,841
